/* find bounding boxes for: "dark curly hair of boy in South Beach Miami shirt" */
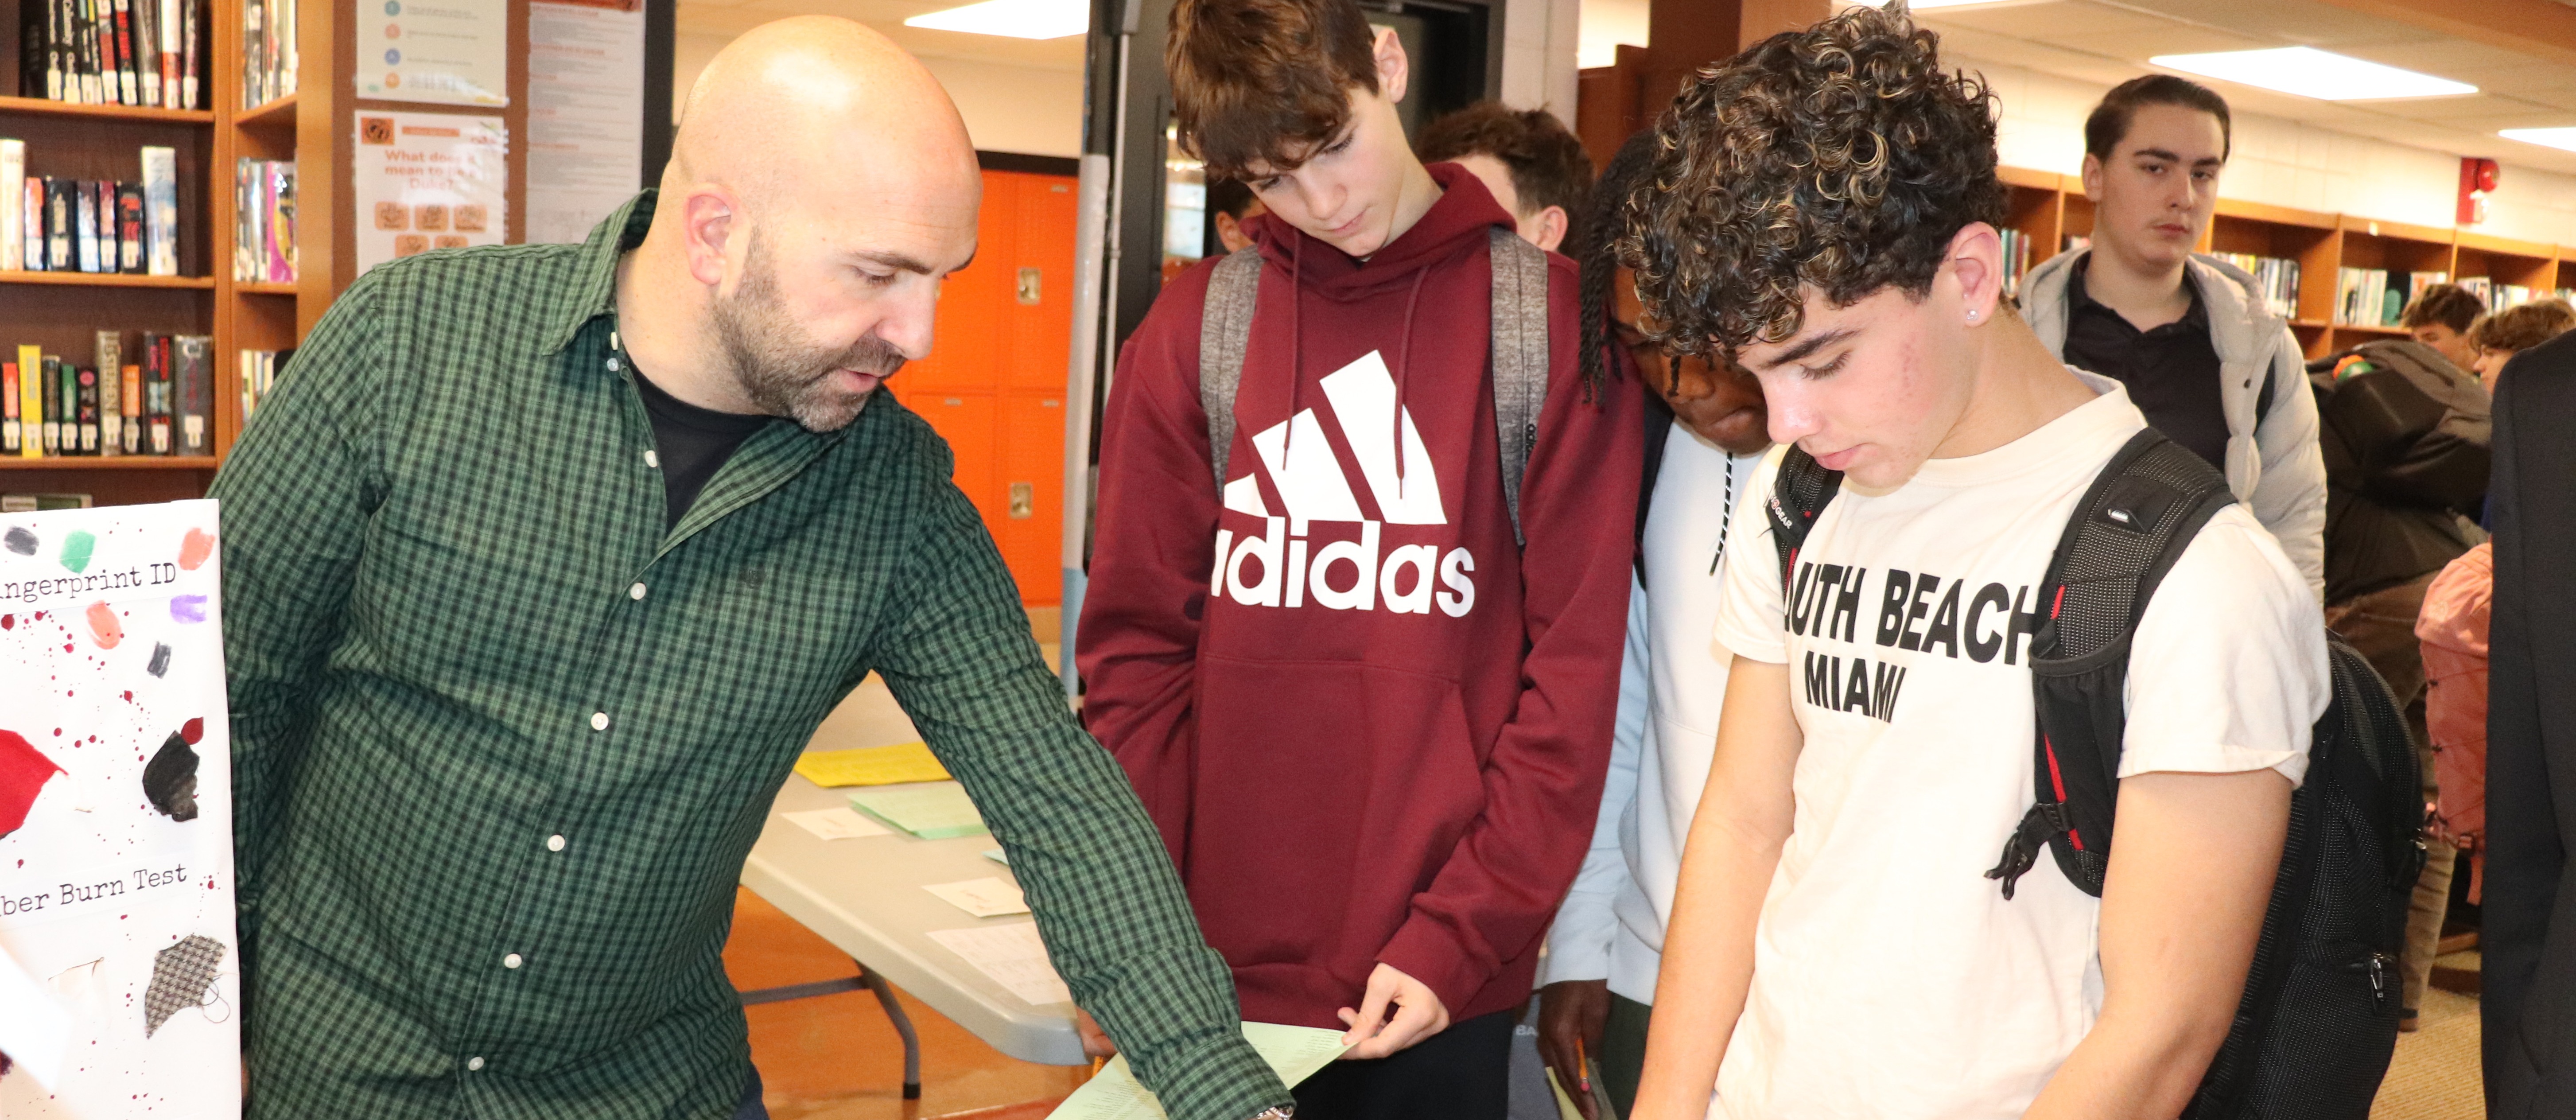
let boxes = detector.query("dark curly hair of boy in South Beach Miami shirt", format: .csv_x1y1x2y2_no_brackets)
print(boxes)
1618,5,2004,355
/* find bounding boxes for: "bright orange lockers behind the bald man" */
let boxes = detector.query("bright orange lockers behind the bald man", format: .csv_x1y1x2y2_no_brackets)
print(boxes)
886,170,1077,605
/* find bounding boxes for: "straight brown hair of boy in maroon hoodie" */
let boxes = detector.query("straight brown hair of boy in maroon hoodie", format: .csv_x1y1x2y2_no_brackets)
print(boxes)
1162,0,1378,178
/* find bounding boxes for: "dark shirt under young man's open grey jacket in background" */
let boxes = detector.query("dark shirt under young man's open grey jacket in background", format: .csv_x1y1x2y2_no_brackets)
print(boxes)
2066,255,2228,471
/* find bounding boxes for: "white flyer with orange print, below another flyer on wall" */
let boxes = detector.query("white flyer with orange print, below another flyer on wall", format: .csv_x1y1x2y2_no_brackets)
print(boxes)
350,111,510,273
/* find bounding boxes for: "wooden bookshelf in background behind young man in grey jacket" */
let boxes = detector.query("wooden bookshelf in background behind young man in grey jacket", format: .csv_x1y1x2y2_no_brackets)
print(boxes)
1997,167,2576,358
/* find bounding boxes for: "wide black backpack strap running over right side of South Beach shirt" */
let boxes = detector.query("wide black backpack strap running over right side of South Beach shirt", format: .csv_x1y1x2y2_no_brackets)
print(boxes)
1986,428,2236,898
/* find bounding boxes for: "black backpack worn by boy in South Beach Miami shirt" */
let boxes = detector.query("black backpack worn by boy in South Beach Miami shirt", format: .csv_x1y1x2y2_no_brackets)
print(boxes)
1767,428,2424,1120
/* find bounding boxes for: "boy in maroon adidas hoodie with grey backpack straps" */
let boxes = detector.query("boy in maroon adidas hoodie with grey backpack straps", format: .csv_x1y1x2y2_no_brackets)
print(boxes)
1074,0,1641,1120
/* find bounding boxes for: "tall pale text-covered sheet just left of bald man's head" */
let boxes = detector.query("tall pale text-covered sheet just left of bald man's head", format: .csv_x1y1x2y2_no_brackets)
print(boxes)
528,0,644,242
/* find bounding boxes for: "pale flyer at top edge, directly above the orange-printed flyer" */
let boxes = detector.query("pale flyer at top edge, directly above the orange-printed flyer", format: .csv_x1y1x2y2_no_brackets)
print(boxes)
355,0,510,105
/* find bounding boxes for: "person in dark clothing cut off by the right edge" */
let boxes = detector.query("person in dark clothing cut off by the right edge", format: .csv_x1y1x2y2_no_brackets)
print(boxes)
2478,322,2576,1120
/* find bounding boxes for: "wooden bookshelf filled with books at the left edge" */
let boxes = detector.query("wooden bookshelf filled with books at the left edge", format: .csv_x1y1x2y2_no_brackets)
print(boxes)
0,0,350,505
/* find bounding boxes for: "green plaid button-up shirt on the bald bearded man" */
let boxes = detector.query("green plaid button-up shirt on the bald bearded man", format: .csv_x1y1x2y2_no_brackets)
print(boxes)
214,193,1288,1120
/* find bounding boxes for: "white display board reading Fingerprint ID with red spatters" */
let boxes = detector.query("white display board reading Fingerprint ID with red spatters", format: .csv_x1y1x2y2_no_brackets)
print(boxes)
0,502,242,1120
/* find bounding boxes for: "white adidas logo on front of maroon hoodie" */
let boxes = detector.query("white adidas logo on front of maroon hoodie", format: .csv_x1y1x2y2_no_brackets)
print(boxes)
1208,350,1476,618
